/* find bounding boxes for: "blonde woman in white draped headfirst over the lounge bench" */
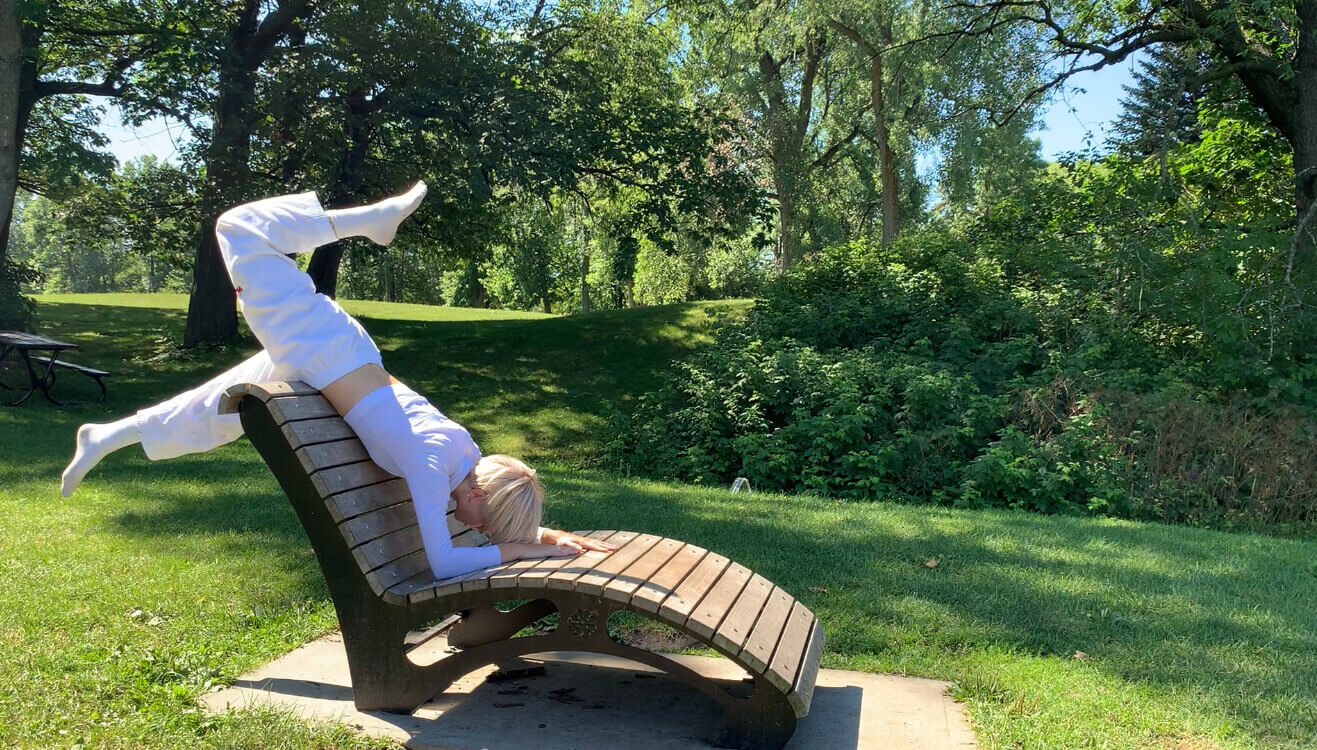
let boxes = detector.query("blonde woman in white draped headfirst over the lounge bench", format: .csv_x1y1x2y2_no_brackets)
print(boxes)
62,183,615,579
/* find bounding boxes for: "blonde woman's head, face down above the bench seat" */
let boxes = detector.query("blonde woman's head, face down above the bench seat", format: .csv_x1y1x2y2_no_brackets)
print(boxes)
453,455,544,544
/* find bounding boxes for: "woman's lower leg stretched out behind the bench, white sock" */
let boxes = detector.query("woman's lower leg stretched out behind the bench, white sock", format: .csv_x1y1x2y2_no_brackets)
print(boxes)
61,351,284,497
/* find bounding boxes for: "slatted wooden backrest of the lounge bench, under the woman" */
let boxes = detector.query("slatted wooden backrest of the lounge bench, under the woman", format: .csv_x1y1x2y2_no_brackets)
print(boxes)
220,381,489,596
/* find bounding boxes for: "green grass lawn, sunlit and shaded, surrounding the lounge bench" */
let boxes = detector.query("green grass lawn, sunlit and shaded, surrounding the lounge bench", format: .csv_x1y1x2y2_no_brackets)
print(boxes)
0,295,1317,749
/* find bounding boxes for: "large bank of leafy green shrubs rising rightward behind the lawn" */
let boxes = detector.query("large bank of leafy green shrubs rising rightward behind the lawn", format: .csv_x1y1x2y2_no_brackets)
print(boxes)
608,119,1317,530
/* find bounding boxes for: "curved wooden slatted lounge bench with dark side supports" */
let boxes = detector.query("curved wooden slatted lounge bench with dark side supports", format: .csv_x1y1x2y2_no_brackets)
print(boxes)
220,381,823,747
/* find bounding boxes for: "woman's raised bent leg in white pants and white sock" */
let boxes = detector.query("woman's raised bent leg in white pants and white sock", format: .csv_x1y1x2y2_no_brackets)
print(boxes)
215,183,425,389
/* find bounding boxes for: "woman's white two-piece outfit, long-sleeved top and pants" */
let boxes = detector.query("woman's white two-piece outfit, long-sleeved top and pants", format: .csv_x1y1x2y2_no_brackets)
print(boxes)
137,192,502,579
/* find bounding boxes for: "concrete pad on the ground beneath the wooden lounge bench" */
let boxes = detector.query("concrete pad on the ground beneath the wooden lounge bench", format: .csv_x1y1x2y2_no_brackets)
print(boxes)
202,633,975,750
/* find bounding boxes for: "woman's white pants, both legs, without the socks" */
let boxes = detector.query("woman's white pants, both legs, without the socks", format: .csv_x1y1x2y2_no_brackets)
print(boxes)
137,192,381,460
